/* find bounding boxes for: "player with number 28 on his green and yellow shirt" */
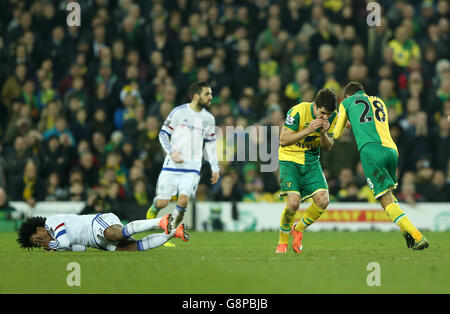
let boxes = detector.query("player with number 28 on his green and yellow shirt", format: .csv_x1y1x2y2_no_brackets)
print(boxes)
334,82,429,250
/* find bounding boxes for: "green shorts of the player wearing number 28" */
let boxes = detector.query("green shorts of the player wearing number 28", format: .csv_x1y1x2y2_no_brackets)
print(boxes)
359,143,398,198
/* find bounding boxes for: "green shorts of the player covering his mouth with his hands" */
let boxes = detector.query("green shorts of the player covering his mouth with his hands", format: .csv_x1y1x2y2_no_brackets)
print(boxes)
280,160,328,201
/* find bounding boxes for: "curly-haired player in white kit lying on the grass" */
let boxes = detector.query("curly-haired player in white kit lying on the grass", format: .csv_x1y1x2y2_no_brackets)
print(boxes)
17,213,189,251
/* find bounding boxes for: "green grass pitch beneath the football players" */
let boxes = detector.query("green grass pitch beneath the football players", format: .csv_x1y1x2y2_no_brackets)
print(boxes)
0,231,450,294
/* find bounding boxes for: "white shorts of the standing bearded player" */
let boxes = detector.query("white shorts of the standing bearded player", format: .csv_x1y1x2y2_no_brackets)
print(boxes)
156,170,200,200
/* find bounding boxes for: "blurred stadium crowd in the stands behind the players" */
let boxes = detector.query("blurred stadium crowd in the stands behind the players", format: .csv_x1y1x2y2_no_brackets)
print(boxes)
0,0,450,219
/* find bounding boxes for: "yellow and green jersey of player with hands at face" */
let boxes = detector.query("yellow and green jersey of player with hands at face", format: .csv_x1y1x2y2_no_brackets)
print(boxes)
278,102,337,165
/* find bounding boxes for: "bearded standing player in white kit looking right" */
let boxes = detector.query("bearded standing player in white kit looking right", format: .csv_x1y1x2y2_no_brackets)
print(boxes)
147,82,219,232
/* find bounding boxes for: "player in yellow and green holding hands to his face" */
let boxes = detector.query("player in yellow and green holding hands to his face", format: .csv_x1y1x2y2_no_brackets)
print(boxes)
275,89,337,253
